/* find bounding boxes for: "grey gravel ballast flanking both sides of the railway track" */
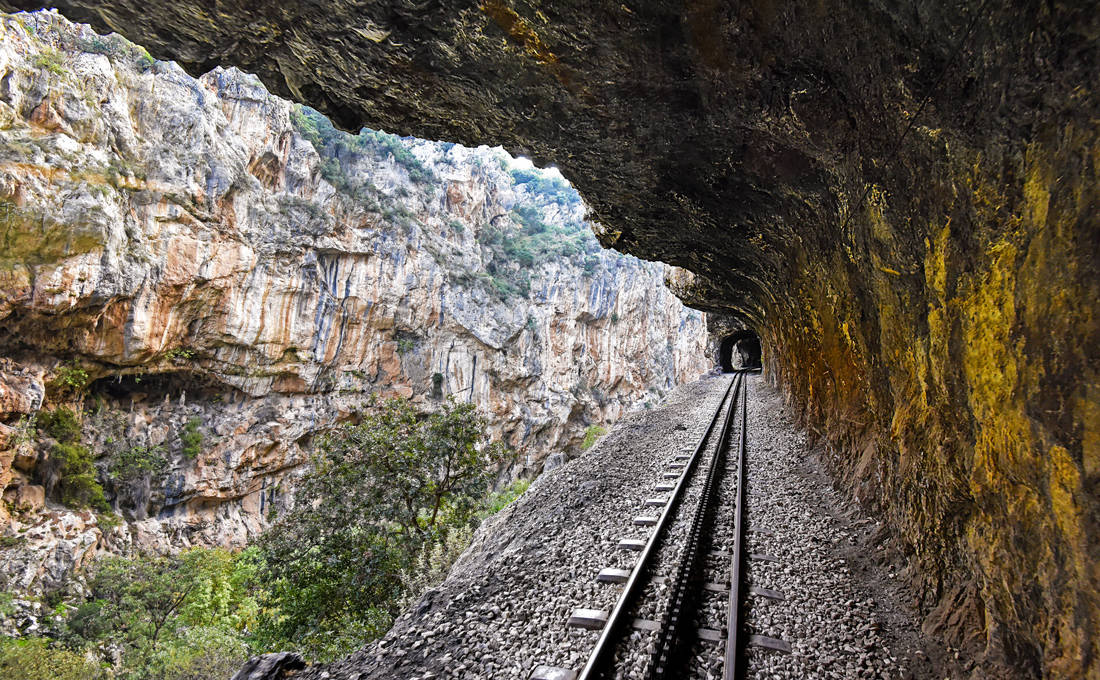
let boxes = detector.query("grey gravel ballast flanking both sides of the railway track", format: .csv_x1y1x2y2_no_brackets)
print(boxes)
300,374,963,680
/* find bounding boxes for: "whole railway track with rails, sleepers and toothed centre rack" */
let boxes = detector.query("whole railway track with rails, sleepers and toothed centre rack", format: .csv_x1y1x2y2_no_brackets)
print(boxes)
528,371,791,680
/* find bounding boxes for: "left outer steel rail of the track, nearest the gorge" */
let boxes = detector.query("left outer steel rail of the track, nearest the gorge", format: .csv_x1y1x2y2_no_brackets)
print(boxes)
576,374,741,680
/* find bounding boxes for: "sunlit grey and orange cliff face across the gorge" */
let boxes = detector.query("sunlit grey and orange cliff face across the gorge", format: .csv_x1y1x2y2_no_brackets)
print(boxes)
0,9,708,589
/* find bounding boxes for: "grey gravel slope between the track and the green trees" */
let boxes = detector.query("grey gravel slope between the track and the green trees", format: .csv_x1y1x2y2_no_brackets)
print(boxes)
298,375,729,680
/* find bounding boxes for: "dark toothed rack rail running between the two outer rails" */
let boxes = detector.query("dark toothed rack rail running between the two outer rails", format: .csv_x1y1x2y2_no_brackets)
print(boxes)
649,374,745,680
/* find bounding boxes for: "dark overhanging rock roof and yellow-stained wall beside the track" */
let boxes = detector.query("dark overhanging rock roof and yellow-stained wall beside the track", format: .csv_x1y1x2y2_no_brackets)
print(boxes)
0,0,1100,677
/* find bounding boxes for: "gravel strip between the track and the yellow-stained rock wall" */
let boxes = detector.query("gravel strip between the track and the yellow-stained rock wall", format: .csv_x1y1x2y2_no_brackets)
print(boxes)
745,376,906,680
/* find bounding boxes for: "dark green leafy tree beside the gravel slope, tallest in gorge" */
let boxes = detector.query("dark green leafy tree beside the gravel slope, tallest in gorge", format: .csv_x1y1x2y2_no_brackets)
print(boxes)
260,398,505,658
